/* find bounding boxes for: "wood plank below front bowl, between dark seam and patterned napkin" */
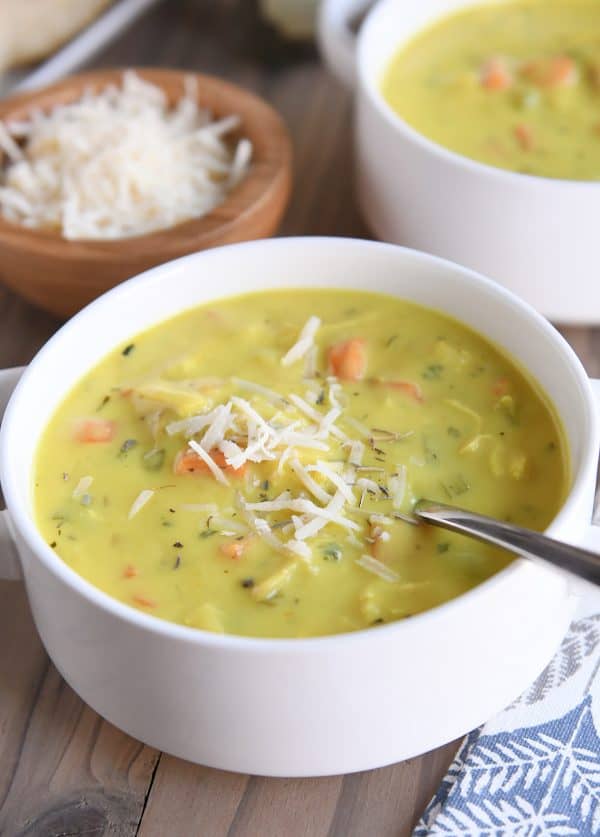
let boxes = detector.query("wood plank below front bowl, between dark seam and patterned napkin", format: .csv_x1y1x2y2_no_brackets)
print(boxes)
139,742,457,837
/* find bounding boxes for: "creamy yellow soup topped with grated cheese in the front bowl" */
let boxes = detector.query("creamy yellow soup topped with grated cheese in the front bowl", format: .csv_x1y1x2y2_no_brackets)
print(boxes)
33,290,568,637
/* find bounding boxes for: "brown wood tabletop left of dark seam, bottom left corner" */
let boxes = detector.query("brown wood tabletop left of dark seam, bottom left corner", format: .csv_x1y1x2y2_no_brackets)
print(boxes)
0,582,159,837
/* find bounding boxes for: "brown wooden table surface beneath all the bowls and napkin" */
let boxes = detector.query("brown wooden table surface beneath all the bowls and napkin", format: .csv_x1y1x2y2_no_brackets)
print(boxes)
0,0,600,837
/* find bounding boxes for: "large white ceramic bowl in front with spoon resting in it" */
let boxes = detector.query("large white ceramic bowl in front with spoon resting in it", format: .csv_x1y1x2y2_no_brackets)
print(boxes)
0,238,599,776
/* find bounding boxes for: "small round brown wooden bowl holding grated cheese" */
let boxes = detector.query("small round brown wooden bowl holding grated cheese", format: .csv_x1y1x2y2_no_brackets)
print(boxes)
0,69,292,317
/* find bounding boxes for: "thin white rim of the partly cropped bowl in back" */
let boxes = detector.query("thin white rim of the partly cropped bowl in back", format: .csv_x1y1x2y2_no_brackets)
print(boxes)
356,0,600,193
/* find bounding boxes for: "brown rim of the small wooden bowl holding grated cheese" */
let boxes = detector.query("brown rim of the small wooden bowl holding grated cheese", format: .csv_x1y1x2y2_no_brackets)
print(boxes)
0,67,292,262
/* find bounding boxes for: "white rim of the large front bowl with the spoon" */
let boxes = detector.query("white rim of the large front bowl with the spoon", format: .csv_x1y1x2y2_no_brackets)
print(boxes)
0,236,599,655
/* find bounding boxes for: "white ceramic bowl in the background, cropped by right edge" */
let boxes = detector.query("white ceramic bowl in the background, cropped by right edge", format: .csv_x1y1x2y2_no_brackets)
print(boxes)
319,0,600,324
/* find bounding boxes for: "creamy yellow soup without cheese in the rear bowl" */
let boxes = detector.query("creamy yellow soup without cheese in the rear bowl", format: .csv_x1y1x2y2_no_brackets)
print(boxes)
382,0,600,180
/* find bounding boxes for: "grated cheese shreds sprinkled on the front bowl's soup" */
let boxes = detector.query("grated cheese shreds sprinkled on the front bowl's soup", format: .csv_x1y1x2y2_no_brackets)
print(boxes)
157,317,408,582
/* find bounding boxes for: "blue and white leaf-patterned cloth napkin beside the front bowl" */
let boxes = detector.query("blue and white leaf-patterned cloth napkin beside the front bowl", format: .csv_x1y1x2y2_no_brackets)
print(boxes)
413,592,600,837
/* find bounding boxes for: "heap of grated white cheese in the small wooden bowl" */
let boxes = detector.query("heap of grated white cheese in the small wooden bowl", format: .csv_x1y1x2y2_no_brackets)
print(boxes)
0,72,252,239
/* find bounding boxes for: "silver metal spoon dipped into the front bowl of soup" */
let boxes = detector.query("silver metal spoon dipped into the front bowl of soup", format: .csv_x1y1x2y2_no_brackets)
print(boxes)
414,500,600,584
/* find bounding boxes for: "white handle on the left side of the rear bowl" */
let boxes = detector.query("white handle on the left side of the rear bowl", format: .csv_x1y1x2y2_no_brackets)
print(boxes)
317,0,373,87
